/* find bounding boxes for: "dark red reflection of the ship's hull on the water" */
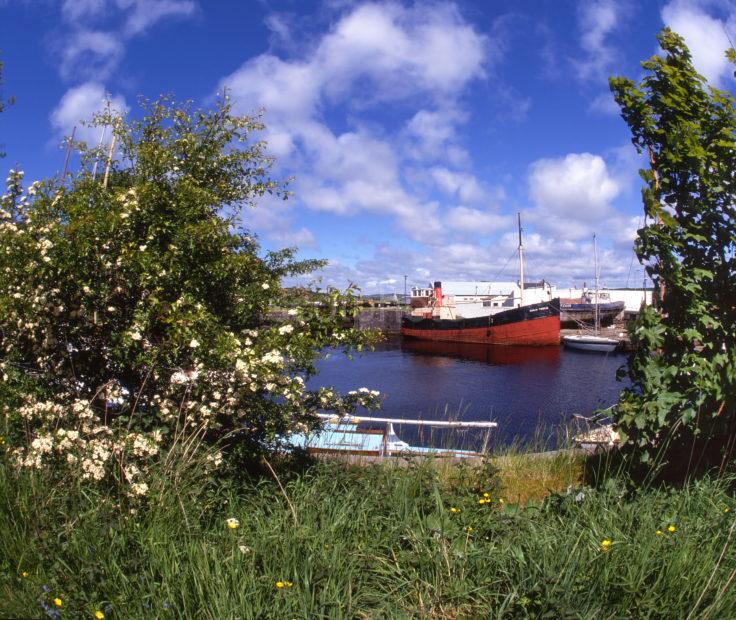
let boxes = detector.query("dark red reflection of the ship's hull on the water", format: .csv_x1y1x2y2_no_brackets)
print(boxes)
401,338,560,366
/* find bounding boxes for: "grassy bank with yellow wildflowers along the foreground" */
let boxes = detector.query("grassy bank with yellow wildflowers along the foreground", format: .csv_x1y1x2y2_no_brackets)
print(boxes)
0,455,736,619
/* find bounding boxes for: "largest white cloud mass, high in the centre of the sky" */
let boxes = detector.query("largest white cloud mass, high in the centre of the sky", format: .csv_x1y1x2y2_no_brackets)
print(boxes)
221,3,488,246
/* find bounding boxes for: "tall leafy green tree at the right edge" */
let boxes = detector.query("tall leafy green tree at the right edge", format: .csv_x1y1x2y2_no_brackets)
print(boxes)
610,29,736,461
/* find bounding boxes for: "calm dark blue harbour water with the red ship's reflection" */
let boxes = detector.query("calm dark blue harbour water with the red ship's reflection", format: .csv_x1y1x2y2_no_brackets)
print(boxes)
309,340,626,443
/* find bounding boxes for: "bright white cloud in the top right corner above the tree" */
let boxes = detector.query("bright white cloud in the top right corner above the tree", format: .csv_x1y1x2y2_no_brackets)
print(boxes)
662,0,736,87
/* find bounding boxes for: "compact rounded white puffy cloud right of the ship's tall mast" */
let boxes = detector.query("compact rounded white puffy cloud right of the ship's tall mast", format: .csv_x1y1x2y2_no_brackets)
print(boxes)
528,153,621,240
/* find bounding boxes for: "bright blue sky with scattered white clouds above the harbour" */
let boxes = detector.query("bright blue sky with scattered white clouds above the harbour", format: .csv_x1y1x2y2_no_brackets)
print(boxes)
0,0,736,292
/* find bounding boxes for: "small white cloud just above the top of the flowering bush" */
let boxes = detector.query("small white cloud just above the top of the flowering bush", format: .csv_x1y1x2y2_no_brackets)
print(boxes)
51,82,128,146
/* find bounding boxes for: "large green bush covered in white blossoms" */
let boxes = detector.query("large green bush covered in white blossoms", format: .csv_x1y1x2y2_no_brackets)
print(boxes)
0,97,378,495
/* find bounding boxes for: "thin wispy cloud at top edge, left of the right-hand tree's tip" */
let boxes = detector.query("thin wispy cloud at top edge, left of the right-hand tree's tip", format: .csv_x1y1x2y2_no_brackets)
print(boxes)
575,0,627,79
